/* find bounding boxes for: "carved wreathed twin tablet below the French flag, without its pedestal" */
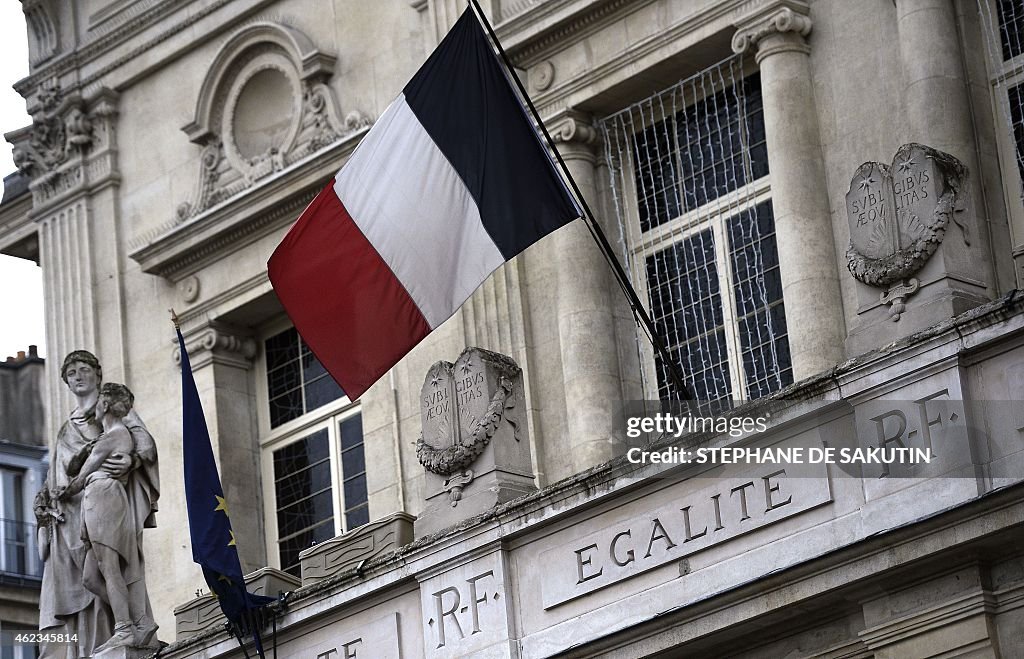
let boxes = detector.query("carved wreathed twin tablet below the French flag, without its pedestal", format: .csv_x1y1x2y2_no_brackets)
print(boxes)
416,348,519,506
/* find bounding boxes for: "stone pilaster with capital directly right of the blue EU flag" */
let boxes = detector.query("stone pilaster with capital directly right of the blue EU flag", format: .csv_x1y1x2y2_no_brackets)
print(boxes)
172,321,266,572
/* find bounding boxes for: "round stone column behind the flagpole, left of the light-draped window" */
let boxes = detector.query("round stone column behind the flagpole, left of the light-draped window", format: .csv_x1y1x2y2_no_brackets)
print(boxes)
550,111,622,472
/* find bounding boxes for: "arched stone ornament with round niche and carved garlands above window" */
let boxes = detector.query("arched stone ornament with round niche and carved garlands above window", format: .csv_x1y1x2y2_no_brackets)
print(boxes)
174,21,371,223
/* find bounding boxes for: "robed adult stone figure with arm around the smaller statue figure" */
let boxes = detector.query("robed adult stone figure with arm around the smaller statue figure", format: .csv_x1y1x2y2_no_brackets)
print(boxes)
35,350,159,659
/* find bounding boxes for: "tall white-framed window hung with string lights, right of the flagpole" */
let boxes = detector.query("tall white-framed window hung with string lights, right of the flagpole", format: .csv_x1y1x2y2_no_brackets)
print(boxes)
602,57,793,401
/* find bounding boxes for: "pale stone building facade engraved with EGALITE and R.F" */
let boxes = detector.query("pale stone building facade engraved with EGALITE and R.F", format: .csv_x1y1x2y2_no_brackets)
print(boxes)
0,0,1024,658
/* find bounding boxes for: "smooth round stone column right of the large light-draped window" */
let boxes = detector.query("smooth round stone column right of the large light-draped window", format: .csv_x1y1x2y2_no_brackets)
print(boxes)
732,0,846,380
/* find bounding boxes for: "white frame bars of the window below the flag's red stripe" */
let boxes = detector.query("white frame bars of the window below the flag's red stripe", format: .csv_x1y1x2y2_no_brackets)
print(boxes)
255,317,369,570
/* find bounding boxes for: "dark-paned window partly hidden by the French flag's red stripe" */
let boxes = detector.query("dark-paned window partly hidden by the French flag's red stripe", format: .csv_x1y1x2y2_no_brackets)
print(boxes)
261,328,370,575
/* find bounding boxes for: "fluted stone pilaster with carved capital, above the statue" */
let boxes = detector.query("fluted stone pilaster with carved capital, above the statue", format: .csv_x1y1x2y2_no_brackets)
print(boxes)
6,83,126,438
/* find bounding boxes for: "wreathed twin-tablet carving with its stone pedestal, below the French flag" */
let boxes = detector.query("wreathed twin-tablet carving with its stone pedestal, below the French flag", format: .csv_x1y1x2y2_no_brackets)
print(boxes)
416,348,536,536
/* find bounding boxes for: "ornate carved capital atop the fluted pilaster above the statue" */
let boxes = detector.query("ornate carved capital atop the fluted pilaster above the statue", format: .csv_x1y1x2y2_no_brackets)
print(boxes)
6,83,118,212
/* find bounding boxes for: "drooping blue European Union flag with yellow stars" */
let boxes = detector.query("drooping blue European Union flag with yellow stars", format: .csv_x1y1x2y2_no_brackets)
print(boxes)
175,326,274,655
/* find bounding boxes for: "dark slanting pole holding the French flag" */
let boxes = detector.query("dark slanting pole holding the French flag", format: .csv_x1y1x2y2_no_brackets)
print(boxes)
469,0,693,400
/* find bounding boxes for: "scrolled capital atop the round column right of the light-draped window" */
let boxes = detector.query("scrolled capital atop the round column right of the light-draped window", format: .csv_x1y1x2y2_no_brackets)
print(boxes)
732,0,812,59
